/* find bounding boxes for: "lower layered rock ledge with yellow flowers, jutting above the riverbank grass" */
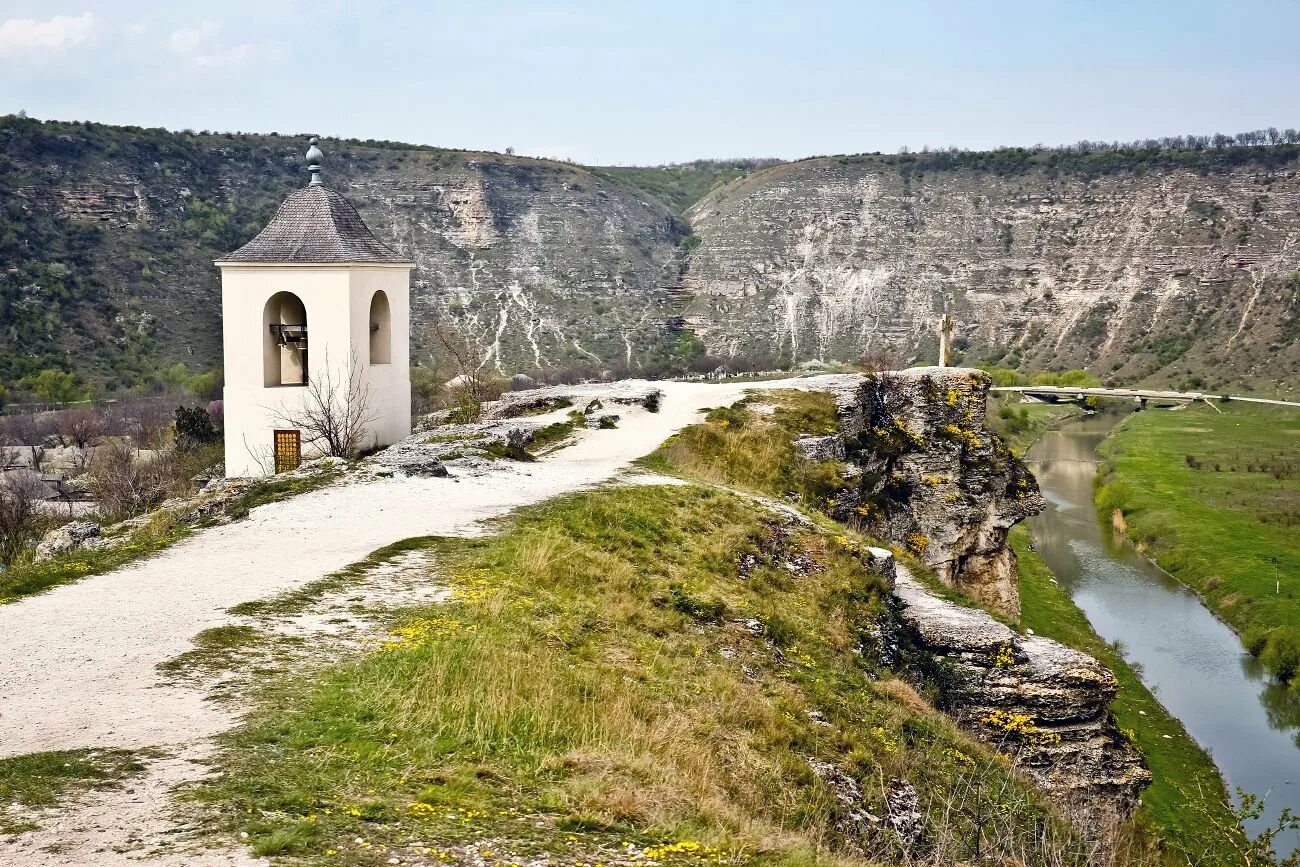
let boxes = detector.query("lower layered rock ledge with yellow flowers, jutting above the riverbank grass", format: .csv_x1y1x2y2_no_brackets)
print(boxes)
894,556,1151,829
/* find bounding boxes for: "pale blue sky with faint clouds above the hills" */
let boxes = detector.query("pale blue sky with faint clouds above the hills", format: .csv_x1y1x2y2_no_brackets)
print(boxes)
0,0,1300,165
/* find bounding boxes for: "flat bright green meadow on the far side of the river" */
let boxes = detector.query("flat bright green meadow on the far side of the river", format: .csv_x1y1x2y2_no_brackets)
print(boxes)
1097,403,1300,675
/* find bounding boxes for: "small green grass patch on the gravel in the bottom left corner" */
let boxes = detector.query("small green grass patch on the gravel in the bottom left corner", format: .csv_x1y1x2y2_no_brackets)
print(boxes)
0,750,154,835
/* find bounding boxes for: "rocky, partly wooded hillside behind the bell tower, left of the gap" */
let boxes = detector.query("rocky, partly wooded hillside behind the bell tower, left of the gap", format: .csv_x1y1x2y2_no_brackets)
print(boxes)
0,117,688,386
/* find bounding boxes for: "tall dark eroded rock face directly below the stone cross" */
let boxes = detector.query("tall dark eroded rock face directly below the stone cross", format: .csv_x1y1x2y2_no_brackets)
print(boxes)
803,368,1047,617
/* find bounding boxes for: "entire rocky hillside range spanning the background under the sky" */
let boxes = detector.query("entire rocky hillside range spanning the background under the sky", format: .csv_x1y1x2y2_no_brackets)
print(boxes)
0,117,1300,390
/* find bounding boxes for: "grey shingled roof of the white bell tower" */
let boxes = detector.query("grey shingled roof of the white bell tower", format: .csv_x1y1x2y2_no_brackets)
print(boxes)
217,183,411,265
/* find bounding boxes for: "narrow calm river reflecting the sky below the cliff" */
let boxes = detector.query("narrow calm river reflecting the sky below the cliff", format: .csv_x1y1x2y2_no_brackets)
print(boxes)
1026,409,1300,853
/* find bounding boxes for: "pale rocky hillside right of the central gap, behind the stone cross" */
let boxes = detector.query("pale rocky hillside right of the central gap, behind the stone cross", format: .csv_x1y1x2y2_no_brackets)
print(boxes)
685,146,1300,387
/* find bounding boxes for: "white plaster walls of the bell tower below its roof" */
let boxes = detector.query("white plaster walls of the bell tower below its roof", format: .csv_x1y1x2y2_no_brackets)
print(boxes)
220,264,411,477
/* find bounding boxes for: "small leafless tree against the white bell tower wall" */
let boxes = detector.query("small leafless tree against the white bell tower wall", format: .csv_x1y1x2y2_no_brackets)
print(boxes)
277,351,377,460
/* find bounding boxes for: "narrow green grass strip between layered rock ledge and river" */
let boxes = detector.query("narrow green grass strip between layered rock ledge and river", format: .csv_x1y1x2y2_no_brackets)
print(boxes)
1010,525,1243,864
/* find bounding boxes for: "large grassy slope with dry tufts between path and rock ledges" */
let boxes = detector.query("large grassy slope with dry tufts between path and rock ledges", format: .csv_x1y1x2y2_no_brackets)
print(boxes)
196,485,1082,864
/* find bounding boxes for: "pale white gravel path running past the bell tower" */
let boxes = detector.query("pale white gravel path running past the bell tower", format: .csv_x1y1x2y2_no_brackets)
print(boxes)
0,382,766,864
